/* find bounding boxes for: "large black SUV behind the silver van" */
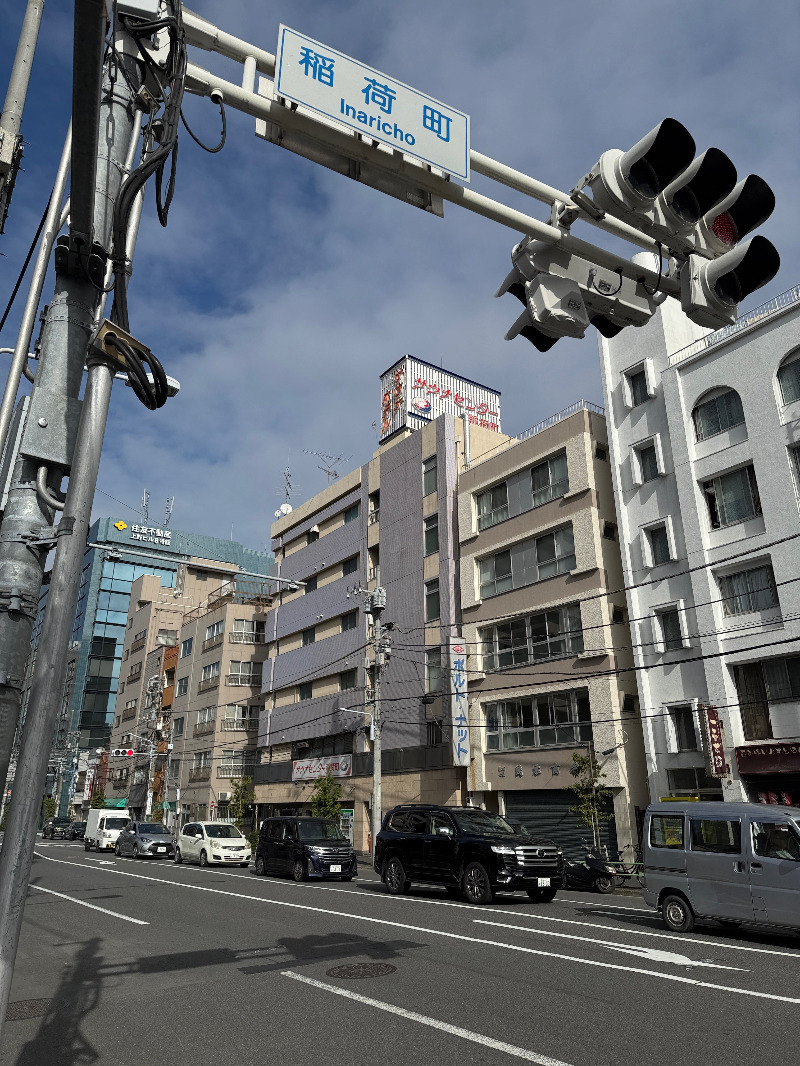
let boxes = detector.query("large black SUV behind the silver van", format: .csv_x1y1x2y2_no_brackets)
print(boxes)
374,804,564,903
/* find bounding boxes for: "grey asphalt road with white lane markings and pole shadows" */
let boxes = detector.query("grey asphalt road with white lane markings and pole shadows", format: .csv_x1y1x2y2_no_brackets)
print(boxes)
0,841,800,1066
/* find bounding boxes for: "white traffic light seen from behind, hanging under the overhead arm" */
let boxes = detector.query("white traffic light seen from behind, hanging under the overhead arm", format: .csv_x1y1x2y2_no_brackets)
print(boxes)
495,237,655,352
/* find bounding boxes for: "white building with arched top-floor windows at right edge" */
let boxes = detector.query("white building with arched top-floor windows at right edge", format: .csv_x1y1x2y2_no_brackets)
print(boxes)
601,287,800,804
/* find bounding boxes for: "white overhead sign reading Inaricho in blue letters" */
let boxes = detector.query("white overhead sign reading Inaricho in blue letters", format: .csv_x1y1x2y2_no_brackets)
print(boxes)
275,26,469,181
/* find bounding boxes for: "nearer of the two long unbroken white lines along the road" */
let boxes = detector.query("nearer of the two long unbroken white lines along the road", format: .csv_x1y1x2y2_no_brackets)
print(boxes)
32,855,800,1004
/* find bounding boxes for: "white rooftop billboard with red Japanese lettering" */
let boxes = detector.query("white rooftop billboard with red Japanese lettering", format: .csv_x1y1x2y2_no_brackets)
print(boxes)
381,355,500,441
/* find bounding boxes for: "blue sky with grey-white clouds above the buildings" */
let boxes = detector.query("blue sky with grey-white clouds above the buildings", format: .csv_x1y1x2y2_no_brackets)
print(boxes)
0,0,800,550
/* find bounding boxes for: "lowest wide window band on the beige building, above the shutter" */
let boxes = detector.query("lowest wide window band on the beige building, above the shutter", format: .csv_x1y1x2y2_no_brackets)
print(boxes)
485,689,592,752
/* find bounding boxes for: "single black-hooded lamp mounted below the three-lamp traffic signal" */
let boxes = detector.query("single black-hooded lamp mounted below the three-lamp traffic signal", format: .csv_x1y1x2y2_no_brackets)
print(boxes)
681,233,781,329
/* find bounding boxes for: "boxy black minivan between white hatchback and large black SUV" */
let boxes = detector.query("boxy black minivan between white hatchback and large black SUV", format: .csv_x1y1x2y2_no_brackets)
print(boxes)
255,818,358,881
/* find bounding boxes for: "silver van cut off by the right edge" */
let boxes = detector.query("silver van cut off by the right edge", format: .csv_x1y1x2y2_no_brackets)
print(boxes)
643,803,800,933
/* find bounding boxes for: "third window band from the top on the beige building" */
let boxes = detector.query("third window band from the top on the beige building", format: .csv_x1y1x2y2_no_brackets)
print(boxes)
478,603,583,673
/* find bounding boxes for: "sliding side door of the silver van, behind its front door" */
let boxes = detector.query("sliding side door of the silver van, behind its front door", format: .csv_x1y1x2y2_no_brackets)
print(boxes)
687,814,755,922
